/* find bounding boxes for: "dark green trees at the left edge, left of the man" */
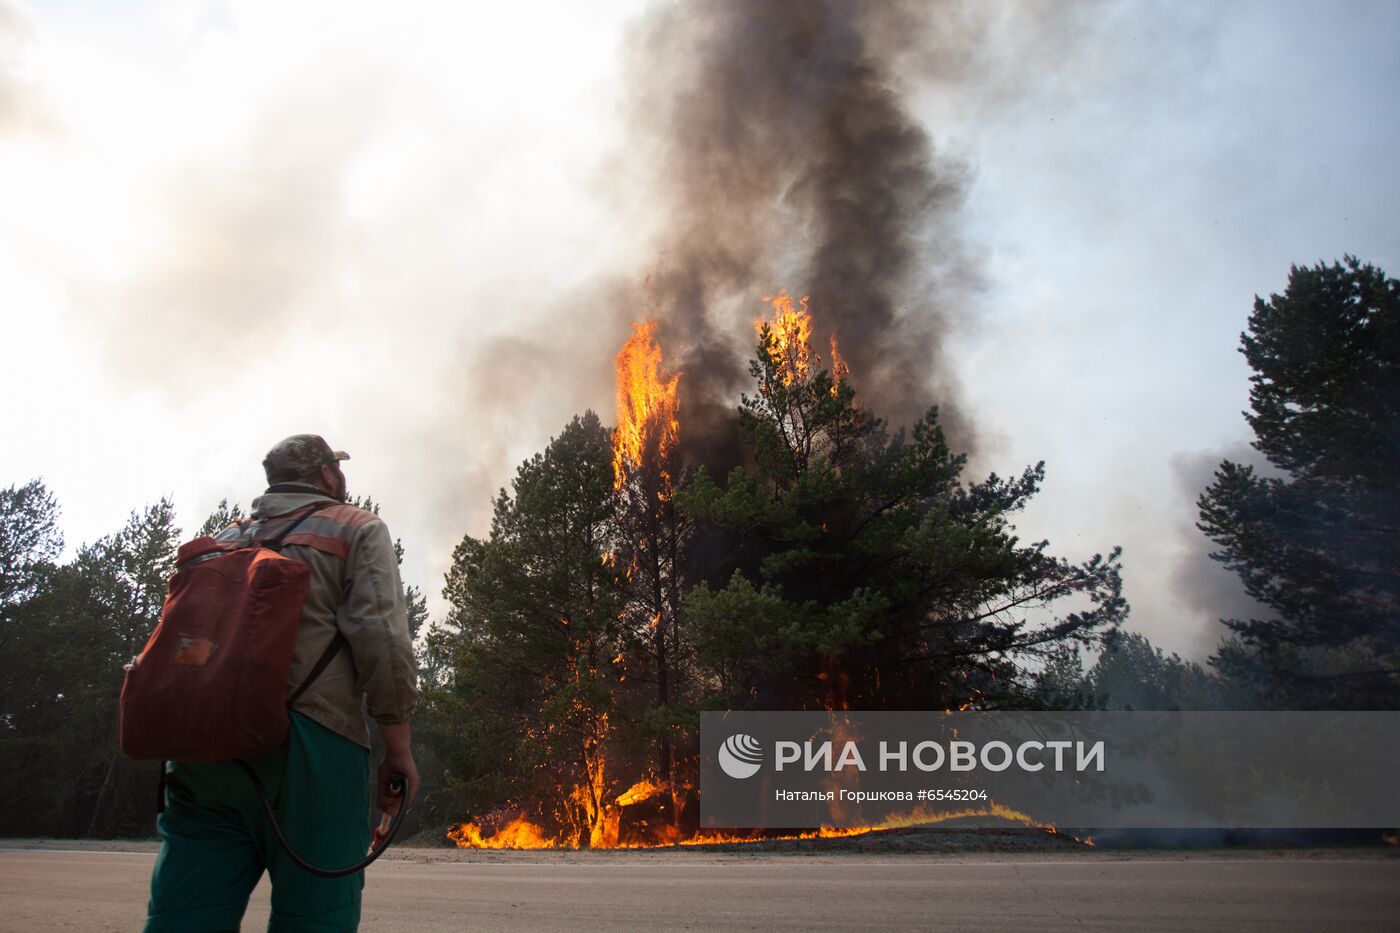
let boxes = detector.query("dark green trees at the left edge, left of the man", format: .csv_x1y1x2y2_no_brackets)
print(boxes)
0,499,179,836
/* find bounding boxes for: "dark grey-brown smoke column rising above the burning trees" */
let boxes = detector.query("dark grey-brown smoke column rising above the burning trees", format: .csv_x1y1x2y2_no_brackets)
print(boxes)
630,0,977,462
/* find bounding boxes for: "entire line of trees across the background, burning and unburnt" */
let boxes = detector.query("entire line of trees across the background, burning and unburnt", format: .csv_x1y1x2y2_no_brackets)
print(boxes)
0,256,1400,845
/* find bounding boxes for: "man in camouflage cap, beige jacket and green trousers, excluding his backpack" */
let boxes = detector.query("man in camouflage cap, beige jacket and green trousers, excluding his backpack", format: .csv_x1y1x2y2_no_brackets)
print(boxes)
146,434,419,933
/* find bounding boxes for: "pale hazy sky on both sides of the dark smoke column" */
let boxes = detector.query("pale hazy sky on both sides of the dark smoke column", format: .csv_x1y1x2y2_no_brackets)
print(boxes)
0,0,1400,658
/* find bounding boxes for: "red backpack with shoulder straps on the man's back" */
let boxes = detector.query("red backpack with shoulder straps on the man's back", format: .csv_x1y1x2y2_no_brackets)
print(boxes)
120,502,343,762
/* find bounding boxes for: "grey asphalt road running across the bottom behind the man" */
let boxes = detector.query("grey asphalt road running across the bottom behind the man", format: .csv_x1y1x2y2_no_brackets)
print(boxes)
0,850,1400,933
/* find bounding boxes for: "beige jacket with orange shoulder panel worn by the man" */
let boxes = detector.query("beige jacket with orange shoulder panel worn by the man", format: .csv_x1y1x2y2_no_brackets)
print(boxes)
218,486,419,748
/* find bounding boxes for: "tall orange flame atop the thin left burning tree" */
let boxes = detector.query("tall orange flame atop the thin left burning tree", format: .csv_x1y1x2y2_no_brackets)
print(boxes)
613,321,680,497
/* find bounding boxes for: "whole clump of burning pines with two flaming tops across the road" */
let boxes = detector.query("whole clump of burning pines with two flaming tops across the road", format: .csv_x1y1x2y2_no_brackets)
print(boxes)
431,294,1124,848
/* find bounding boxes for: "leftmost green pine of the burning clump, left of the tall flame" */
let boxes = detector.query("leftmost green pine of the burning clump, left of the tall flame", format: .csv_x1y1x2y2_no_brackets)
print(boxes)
427,412,626,845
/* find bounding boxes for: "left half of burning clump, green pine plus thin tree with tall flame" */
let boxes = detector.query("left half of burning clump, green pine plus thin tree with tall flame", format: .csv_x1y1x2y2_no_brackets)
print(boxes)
436,322,696,848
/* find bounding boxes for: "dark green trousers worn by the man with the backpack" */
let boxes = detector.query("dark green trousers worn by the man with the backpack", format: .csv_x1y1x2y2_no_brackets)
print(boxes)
146,713,370,933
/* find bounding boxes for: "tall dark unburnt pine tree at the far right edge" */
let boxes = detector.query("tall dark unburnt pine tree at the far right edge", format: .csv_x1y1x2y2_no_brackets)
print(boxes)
1198,256,1400,707
